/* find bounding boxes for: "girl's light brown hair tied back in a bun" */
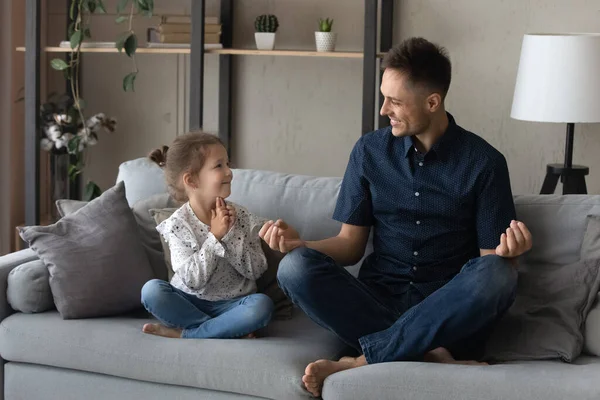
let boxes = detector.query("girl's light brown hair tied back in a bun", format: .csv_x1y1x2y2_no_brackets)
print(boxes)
148,132,223,203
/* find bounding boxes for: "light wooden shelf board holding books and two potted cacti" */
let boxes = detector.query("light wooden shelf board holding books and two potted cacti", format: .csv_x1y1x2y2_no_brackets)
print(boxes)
17,47,384,58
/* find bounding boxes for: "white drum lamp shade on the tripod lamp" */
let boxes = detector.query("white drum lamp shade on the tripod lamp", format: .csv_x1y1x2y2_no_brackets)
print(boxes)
510,34,600,123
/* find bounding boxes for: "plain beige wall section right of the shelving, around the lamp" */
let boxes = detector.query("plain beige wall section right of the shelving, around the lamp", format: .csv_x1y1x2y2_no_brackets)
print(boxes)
395,0,600,194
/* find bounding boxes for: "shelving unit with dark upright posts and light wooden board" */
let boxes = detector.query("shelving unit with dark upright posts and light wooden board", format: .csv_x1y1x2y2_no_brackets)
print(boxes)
22,0,394,225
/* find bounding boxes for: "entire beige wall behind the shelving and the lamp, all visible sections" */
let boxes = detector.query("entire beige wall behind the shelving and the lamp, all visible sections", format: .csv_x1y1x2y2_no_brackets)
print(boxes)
52,0,600,194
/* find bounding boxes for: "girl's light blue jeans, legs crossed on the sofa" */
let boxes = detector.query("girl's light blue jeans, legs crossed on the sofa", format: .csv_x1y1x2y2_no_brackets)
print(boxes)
142,279,275,339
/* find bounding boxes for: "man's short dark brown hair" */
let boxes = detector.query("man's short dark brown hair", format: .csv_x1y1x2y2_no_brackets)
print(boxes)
381,37,452,99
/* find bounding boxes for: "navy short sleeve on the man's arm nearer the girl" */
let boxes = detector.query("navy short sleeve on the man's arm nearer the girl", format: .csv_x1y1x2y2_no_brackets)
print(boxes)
333,140,373,226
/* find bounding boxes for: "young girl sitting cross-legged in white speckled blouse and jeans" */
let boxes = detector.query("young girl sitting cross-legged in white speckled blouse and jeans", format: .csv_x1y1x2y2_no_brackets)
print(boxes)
142,133,274,338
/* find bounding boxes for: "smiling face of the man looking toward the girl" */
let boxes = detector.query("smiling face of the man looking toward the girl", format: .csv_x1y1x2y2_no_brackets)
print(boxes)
380,68,431,137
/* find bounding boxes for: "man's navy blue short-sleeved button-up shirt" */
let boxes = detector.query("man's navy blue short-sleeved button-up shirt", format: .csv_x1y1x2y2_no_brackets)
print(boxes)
333,113,516,297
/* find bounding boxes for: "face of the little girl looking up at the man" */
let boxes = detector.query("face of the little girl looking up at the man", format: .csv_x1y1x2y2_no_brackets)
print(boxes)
186,145,233,203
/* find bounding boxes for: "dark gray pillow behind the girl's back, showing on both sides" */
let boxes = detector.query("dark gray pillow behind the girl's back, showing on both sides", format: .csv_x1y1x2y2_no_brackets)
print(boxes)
150,208,293,319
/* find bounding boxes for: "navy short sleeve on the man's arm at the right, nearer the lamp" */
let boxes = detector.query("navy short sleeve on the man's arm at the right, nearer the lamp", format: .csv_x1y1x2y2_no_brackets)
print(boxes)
475,155,516,249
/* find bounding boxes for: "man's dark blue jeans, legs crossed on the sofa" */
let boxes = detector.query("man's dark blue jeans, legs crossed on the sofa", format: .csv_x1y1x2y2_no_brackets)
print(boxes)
277,248,517,364
